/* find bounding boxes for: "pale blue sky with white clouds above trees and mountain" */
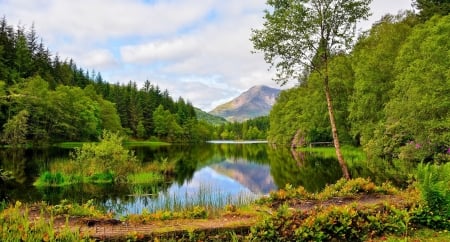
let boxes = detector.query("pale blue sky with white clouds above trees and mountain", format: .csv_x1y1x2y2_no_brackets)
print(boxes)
0,0,412,111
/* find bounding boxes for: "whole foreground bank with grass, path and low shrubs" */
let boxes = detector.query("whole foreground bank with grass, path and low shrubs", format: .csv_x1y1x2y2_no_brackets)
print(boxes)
0,175,450,241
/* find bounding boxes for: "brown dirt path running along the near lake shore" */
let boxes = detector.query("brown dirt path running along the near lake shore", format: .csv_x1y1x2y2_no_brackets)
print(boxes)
30,195,396,241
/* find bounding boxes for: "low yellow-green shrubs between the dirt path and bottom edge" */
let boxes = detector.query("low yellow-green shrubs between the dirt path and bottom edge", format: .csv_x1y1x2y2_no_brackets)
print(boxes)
248,199,409,241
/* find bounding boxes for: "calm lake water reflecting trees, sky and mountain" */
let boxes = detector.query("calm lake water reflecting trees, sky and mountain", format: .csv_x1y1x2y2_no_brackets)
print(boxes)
0,142,413,214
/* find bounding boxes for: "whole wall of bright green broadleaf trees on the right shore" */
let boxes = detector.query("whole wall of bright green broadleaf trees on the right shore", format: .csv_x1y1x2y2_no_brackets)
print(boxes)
268,11,450,161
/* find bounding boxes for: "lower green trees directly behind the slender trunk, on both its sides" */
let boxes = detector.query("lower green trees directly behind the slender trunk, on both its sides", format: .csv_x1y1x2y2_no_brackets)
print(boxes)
268,56,353,146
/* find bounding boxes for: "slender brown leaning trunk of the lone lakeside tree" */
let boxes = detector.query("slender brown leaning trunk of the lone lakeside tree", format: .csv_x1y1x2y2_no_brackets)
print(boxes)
324,66,350,180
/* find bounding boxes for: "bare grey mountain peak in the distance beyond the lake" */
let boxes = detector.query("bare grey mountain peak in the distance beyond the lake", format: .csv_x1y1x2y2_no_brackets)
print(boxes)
209,86,280,121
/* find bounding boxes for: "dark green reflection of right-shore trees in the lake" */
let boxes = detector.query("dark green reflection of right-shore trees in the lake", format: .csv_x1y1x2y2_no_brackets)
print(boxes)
268,147,415,192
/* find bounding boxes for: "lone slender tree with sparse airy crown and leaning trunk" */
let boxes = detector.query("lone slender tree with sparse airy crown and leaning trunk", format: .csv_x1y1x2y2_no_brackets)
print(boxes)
251,0,371,179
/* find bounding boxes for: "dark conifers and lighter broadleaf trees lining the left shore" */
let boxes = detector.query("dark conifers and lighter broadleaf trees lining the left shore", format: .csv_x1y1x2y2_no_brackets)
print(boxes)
0,17,213,144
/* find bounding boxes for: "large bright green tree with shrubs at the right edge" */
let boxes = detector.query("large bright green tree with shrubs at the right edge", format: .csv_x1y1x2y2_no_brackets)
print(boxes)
367,16,450,162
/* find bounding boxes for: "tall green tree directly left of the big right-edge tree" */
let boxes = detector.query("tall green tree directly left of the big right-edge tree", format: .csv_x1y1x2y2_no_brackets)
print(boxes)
348,13,417,145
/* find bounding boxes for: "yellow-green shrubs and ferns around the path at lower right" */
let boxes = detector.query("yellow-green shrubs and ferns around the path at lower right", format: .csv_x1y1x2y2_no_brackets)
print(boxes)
247,168,450,241
